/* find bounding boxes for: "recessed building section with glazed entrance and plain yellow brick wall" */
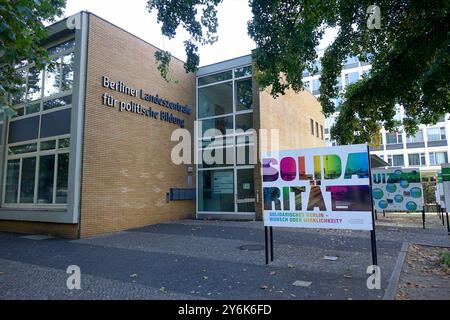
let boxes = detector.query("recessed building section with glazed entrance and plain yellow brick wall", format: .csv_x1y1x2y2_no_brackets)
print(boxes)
197,55,325,219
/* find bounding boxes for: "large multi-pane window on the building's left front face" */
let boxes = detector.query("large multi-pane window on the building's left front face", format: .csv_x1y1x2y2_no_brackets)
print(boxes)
3,39,75,207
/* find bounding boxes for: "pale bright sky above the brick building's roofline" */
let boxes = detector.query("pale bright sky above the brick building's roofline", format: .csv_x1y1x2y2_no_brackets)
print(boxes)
64,0,336,66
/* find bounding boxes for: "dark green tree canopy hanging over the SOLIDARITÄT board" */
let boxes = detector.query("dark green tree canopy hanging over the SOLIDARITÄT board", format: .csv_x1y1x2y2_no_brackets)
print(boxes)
148,0,450,144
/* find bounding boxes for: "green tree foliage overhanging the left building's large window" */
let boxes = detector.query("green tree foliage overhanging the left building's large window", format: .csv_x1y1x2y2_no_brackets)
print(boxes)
0,0,66,114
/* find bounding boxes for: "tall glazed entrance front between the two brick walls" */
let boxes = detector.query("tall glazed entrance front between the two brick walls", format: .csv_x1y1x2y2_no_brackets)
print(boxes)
197,66,256,214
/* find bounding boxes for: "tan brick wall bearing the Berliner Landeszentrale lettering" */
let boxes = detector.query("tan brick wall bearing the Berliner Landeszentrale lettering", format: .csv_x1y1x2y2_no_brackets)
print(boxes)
81,15,195,237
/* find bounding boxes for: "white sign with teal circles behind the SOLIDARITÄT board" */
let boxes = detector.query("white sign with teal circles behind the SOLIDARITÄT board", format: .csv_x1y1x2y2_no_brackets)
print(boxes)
372,167,424,211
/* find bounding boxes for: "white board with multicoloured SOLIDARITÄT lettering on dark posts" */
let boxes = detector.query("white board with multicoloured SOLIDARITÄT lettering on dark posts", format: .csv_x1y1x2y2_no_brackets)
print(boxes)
262,145,373,230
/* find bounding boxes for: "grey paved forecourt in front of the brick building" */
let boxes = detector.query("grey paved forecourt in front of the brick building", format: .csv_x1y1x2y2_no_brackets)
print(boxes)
0,215,450,300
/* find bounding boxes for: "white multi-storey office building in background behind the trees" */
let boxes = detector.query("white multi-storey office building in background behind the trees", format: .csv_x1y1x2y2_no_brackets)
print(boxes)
303,50,450,180
